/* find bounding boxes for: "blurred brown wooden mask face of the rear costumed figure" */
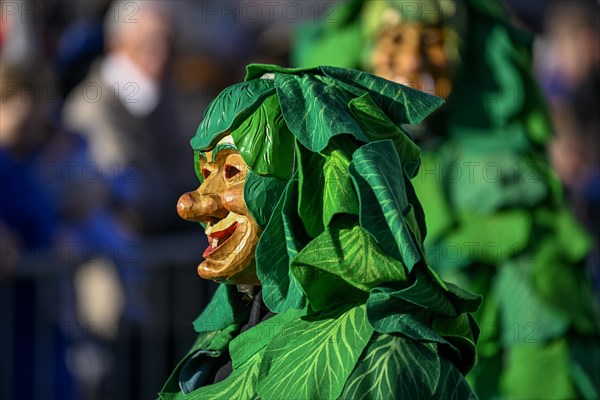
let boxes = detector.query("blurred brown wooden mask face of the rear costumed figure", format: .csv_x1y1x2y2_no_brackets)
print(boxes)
371,22,450,98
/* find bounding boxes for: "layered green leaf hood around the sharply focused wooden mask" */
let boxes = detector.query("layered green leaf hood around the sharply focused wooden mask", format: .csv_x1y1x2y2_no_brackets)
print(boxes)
191,64,480,371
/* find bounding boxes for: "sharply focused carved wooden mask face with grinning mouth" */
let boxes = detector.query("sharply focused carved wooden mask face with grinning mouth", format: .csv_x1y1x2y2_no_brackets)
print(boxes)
177,135,261,285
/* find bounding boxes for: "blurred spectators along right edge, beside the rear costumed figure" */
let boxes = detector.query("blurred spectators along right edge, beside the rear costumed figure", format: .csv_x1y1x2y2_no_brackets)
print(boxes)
536,1,600,288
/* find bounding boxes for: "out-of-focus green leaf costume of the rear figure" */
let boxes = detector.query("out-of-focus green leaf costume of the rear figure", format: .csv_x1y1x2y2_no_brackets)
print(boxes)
295,0,600,399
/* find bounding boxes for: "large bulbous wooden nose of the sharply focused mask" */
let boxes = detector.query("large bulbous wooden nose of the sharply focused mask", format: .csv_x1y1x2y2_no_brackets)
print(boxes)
177,190,228,223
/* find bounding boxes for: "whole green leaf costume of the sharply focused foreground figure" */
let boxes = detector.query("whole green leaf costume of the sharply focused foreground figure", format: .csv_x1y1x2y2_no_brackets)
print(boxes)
160,65,480,399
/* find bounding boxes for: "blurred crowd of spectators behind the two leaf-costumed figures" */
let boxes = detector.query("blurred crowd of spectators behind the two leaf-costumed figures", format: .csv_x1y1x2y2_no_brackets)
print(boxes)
0,0,600,400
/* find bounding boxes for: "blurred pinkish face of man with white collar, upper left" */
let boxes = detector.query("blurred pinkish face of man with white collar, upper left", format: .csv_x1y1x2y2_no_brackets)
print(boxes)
109,8,172,81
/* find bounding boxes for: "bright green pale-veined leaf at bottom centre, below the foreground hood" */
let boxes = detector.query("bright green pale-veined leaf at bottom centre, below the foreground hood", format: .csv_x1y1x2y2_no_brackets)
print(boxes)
258,306,373,399
